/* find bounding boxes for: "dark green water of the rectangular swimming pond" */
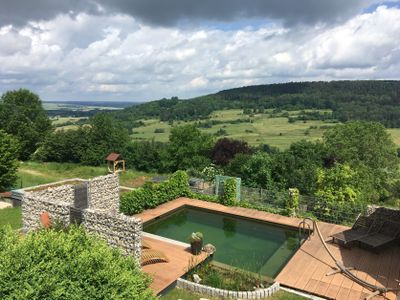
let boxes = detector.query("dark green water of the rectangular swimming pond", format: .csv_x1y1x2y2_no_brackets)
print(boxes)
144,207,301,278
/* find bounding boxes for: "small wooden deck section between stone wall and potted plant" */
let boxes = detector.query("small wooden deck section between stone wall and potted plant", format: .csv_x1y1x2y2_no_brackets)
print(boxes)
142,237,208,294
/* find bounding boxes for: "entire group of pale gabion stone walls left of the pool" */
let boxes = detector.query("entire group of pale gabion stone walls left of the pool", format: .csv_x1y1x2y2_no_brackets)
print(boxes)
22,174,142,259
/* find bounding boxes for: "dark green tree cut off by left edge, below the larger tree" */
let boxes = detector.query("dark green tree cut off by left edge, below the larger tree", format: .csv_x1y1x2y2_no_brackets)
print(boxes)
0,130,19,192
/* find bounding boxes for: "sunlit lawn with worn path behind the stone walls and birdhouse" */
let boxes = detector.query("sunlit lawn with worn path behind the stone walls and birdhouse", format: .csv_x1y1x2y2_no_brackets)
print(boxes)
16,161,155,188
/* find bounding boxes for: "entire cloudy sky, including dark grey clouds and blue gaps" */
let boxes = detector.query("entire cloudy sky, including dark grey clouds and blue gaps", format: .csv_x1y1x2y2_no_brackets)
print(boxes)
0,0,400,101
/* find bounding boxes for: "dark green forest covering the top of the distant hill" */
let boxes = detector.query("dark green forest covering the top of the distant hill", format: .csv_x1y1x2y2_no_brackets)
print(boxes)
113,80,400,128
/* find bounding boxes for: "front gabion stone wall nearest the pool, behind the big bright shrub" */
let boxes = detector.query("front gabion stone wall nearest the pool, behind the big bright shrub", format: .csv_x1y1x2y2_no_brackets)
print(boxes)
82,209,142,258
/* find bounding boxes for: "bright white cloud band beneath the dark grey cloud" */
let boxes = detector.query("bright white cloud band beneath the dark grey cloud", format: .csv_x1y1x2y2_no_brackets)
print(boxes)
0,6,400,100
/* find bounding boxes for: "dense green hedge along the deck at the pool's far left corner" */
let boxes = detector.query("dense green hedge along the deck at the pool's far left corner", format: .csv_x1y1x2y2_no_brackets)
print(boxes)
120,171,191,215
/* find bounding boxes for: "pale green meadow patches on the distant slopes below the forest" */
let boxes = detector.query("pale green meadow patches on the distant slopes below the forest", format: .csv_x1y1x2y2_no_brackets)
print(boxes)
47,109,400,149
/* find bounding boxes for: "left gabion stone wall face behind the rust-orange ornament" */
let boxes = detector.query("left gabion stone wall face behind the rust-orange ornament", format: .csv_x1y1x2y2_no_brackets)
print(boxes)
21,193,70,231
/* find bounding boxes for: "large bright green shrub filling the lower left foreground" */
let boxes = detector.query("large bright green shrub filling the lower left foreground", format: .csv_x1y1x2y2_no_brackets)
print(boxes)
0,226,155,300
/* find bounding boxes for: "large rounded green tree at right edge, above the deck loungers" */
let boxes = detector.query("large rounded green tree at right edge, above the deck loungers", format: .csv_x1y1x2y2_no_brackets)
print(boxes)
324,121,399,201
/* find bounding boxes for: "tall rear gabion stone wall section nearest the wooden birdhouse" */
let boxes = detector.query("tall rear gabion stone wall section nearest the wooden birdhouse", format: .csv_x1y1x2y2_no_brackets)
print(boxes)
88,174,119,212
